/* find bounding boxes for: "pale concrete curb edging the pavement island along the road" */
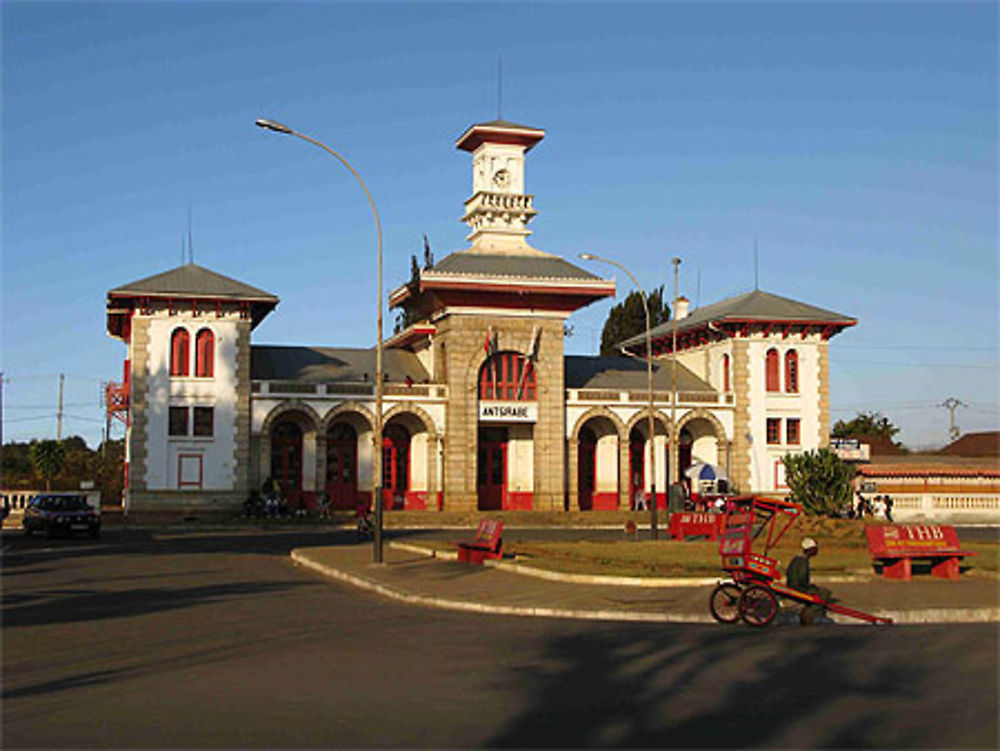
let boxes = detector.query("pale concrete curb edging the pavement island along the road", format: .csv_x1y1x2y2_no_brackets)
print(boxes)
291,543,1000,626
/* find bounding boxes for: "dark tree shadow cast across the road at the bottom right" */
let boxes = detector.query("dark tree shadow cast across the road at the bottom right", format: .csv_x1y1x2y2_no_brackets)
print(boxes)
484,626,997,748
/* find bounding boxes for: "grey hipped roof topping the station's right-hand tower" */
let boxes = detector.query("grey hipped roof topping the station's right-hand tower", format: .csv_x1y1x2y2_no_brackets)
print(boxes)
622,290,857,347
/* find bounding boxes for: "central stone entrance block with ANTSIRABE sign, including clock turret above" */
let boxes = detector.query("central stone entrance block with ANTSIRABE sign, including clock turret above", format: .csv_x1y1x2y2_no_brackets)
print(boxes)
389,120,615,510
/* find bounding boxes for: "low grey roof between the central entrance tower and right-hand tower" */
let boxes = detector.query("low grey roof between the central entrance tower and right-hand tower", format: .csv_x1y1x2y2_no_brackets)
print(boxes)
563,355,715,392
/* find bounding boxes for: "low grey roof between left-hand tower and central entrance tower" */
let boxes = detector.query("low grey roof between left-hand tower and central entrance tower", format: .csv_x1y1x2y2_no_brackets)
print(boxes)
250,344,430,383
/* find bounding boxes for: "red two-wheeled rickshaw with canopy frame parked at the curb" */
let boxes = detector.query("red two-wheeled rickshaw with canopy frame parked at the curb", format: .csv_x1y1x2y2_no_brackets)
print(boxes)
709,496,892,627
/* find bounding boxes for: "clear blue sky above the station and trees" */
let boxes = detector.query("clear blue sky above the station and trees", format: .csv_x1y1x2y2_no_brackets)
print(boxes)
2,2,1000,446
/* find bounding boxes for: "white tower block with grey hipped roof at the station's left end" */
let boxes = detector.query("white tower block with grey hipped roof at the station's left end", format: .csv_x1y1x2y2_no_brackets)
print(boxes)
107,263,278,509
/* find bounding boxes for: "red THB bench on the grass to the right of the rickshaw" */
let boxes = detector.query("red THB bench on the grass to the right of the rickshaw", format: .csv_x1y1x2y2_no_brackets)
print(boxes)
865,524,976,581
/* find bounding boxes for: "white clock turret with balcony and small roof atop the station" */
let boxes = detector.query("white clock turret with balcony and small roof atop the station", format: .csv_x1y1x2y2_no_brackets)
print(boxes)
455,120,545,255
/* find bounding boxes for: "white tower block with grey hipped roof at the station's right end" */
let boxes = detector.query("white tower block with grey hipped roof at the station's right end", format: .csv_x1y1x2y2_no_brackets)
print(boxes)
623,290,857,492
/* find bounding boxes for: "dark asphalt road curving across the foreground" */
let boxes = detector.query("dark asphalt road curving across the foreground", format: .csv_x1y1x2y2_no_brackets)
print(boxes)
2,530,998,748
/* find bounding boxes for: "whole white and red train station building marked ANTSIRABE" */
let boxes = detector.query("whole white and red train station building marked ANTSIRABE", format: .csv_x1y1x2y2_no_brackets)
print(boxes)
107,120,856,511
